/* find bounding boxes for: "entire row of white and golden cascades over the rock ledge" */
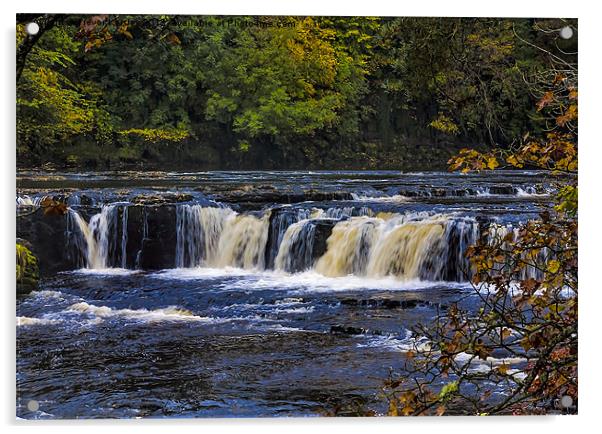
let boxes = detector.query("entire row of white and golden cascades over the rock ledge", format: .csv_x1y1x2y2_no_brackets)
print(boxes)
64,204,488,281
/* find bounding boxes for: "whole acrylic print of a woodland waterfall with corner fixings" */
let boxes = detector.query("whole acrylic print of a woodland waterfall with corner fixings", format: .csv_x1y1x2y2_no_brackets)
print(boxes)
16,14,578,419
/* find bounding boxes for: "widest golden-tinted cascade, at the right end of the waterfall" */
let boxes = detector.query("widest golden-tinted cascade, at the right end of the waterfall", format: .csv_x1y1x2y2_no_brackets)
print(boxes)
315,214,478,280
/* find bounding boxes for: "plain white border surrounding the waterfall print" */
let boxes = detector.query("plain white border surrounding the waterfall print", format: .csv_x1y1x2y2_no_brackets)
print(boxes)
0,0,602,434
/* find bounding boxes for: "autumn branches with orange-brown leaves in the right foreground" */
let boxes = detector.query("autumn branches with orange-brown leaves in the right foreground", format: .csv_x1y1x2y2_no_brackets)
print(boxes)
384,45,578,415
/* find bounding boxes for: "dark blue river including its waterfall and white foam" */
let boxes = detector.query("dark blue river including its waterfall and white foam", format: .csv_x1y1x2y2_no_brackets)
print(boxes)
17,172,554,418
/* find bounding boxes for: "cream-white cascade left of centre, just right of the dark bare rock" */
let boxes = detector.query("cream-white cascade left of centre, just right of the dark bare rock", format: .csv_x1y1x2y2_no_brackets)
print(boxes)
176,205,270,269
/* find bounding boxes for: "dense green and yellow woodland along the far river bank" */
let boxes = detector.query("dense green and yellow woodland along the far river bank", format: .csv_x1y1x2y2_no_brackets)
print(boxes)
17,15,577,170
